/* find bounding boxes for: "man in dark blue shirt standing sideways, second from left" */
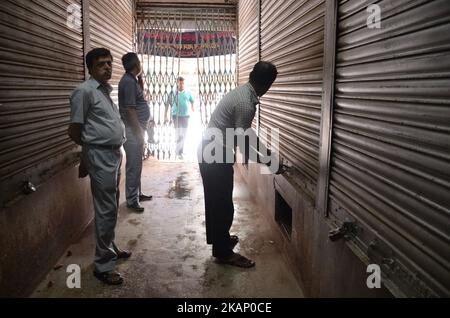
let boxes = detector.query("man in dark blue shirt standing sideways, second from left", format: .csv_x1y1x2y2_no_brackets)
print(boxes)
119,53,152,212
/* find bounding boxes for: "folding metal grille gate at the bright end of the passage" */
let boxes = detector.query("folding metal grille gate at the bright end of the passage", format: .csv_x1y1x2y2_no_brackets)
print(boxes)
136,7,237,160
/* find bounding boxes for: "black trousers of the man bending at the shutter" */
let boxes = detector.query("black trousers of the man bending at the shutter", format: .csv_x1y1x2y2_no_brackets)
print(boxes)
200,163,234,258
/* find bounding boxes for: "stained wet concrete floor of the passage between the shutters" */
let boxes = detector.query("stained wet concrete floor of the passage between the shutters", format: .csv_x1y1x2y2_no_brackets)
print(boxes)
31,159,303,298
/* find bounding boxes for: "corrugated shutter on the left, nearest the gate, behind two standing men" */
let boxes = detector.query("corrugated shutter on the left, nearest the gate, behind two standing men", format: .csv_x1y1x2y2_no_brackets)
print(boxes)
90,0,134,103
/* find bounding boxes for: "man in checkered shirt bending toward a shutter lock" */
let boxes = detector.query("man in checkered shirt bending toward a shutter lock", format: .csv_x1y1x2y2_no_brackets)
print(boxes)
199,62,281,268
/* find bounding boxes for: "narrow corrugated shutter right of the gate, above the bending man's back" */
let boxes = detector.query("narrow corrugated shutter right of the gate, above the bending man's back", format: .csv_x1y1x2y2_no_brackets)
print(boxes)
238,0,259,85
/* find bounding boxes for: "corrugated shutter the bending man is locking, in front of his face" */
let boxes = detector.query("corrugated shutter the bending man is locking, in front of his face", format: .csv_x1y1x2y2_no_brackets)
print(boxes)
260,0,325,191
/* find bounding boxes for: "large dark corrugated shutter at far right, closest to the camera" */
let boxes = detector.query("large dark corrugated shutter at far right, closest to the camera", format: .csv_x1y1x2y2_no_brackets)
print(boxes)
330,0,450,296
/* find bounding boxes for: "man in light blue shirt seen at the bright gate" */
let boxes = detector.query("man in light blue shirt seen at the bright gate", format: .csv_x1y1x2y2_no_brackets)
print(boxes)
165,77,195,159
